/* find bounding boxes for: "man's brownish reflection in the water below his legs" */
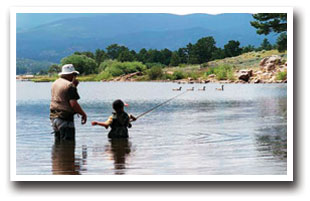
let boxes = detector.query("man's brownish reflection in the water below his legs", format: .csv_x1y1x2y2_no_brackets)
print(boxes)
52,139,81,175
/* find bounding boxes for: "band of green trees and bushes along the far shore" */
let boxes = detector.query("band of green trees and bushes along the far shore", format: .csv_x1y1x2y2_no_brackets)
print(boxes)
48,36,279,76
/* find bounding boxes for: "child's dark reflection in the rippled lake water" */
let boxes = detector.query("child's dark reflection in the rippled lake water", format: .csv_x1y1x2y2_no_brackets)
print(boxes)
106,138,131,174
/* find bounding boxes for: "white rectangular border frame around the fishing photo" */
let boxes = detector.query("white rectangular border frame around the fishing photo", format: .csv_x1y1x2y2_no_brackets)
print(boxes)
10,7,293,181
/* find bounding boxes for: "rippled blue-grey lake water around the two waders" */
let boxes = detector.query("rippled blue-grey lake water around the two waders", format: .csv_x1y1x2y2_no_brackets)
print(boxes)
16,81,287,175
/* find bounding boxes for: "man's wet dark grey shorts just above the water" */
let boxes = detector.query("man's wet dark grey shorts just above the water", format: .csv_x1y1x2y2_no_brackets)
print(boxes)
51,118,75,140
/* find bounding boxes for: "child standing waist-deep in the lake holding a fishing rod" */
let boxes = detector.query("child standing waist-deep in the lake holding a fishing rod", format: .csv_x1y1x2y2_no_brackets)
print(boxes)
91,100,136,138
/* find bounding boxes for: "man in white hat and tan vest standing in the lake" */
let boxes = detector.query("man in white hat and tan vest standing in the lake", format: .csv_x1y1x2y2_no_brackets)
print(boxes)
50,64,87,140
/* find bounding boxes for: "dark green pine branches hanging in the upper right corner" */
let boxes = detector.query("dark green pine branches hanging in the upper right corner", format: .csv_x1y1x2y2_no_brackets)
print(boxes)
250,13,287,35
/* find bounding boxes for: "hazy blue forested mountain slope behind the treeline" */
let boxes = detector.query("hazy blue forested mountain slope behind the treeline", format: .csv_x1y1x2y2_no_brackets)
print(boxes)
17,13,276,63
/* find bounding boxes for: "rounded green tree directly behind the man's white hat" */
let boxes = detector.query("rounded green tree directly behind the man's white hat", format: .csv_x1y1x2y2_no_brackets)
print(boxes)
61,54,97,75
